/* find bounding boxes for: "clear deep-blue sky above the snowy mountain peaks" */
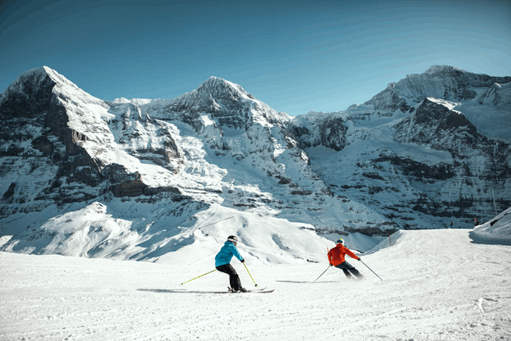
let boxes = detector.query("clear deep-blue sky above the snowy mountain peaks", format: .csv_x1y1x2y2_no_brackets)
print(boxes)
0,0,511,116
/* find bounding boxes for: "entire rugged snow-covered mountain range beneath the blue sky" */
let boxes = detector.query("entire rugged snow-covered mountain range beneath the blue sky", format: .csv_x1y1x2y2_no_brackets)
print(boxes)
0,66,511,261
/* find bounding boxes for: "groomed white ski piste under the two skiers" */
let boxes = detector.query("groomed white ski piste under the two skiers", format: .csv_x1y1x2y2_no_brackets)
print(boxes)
0,230,511,341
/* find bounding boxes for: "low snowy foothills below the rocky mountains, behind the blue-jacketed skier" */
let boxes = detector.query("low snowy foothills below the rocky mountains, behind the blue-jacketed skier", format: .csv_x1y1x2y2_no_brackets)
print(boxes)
0,202,344,264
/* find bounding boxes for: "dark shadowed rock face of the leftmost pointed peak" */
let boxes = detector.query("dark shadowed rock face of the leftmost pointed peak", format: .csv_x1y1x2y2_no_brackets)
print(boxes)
0,68,105,210
